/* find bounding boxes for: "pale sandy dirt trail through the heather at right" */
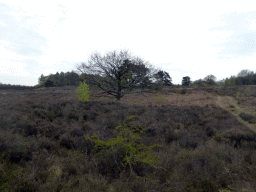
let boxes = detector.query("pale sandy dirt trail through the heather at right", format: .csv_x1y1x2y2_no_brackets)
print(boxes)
216,95,256,132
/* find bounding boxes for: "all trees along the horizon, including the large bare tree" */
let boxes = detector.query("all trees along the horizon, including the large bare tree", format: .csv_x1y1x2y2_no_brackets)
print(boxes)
35,50,256,94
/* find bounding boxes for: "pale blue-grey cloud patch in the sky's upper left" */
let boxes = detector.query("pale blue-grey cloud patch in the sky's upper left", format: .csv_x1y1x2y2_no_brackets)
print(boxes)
0,3,48,56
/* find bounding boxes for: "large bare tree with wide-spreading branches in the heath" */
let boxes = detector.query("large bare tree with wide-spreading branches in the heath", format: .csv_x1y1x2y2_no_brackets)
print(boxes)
77,50,155,100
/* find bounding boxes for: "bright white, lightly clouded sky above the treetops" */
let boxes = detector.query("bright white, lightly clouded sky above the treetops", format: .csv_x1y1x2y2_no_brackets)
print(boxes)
0,0,256,86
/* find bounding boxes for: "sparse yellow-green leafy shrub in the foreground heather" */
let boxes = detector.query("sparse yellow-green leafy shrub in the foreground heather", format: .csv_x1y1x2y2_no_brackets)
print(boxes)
85,116,165,182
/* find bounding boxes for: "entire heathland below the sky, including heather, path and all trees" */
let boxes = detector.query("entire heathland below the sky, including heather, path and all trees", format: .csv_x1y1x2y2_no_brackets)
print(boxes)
0,52,256,192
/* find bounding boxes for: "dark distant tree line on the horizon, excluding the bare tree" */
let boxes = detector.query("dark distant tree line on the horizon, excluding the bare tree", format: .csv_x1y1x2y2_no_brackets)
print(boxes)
35,65,256,88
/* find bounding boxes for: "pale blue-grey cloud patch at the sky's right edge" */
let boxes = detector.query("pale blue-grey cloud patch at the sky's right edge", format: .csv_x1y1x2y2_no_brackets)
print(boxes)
210,11,256,58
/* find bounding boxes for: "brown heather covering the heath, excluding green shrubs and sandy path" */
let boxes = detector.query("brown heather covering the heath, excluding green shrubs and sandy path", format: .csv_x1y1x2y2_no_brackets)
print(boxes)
0,87,256,191
